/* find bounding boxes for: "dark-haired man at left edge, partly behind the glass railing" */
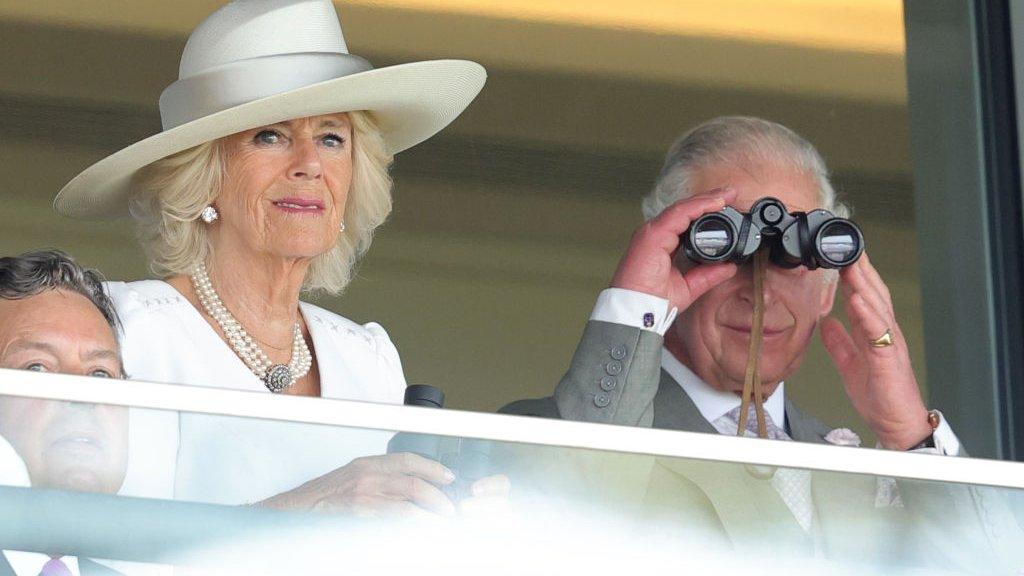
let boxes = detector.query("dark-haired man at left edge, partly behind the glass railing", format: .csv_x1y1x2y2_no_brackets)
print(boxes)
0,250,128,576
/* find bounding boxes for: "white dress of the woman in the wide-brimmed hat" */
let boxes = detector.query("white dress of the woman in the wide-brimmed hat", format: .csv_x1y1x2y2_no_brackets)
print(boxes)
106,281,406,504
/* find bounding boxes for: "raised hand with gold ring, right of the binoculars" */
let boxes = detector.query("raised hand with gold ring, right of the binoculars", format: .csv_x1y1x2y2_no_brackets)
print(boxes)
821,253,932,450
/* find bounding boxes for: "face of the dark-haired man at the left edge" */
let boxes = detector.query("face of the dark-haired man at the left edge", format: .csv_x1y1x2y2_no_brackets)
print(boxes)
0,290,128,494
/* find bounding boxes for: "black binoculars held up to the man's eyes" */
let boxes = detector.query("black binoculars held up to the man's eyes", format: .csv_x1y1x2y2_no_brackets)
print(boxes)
682,198,864,270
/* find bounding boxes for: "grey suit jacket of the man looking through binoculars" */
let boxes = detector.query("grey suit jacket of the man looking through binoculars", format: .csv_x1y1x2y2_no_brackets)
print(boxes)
502,321,1019,569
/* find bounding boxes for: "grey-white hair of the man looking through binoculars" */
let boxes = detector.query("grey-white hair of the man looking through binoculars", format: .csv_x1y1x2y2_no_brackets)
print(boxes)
641,116,850,220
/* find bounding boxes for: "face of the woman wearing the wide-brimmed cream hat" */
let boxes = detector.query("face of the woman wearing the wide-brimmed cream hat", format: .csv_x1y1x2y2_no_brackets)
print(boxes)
211,114,352,259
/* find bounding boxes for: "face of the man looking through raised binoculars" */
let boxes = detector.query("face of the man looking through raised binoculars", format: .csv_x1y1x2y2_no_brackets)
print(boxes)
666,162,836,394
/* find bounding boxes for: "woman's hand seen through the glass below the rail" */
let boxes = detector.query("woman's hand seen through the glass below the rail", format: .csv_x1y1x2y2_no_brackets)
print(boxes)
260,452,458,517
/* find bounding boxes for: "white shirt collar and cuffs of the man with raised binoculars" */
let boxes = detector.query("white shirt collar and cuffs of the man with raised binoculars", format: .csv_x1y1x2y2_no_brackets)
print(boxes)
590,288,961,456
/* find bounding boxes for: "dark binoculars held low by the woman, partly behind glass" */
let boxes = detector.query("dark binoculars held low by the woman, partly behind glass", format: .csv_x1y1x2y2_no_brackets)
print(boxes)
387,384,494,502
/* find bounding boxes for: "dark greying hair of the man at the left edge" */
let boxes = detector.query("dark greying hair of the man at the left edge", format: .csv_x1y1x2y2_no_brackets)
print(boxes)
0,250,121,334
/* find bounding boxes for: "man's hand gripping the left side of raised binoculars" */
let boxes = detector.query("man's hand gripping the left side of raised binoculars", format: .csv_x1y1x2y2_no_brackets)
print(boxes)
611,189,736,312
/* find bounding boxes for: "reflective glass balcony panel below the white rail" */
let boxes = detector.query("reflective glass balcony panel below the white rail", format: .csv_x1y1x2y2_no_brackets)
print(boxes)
0,391,1024,574
